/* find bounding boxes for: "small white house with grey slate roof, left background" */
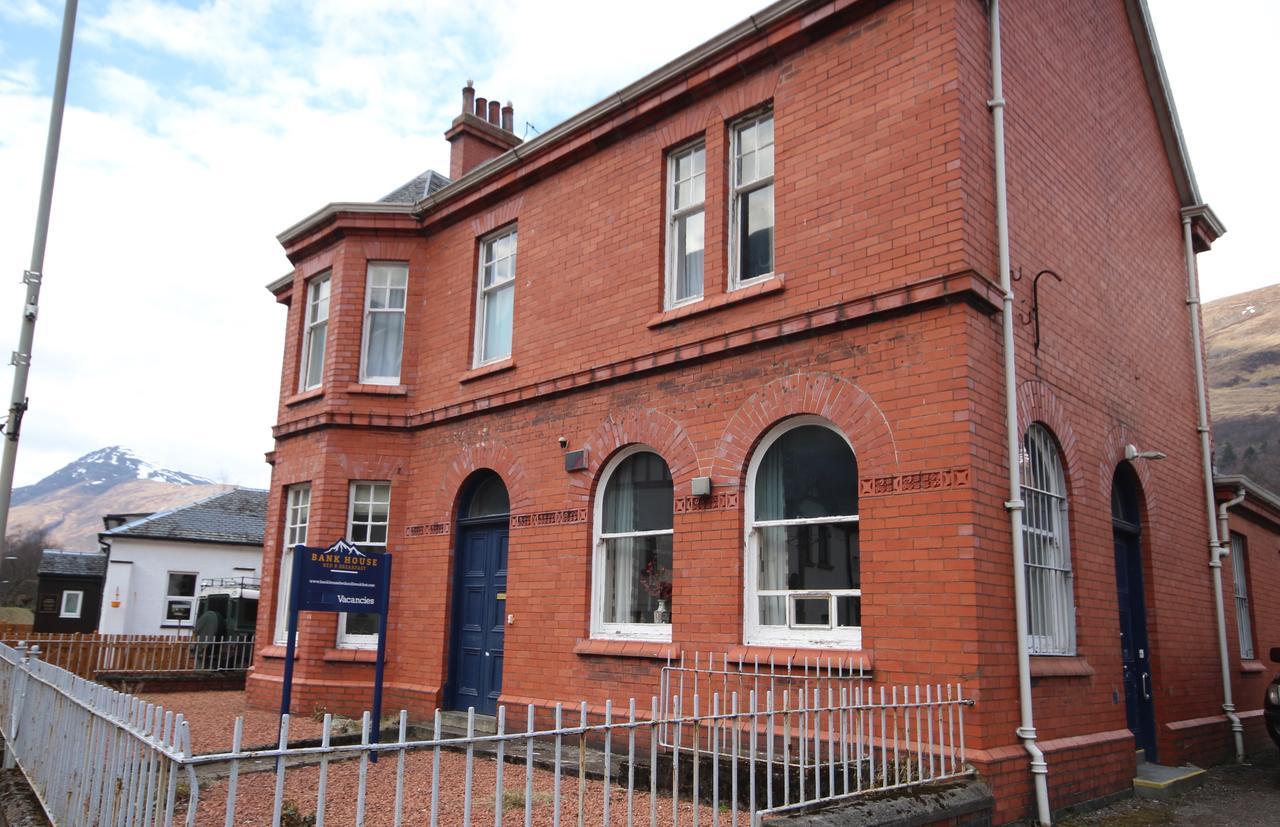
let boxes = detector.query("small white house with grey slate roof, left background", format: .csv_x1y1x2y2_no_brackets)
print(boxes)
99,488,266,635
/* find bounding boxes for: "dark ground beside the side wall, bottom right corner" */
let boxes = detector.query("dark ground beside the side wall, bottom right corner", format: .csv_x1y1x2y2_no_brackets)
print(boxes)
1057,751,1280,827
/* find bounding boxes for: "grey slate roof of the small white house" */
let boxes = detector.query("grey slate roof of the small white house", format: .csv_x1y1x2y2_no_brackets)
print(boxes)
99,488,266,545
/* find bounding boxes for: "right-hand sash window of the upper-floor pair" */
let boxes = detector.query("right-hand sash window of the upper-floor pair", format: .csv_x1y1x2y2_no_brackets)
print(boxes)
728,110,773,289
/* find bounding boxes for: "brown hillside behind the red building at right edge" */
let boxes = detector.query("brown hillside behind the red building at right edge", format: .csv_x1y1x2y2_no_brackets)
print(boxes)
1204,284,1280,492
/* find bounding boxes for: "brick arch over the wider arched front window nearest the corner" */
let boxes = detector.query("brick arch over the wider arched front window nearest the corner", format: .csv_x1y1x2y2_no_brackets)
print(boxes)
712,373,899,486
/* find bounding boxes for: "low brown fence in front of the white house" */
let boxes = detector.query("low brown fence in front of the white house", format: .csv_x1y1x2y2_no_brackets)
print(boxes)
0,632,253,680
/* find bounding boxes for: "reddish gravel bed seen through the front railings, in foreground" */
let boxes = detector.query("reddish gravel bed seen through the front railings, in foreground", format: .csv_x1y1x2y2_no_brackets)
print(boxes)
196,753,721,827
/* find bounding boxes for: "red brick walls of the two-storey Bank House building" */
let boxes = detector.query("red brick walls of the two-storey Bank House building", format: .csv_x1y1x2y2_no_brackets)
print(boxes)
248,0,1254,821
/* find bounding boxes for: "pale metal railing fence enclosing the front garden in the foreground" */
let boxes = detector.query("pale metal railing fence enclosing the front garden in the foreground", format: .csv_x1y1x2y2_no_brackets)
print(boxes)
0,646,973,827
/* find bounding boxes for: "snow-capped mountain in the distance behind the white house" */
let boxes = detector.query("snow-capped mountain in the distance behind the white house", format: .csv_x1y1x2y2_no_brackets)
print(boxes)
9,446,232,552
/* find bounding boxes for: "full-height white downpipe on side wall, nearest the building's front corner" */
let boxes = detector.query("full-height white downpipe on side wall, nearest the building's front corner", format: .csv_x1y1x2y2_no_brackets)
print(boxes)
987,0,1052,826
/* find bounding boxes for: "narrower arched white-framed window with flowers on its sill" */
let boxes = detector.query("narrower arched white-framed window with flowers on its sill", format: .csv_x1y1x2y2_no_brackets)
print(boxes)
591,446,675,640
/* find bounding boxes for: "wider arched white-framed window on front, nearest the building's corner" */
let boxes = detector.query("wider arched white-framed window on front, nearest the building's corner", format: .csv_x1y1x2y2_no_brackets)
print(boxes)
744,416,863,649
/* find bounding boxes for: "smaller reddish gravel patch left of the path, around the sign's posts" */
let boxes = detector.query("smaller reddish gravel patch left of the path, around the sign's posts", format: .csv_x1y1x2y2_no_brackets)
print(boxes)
141,691,323,754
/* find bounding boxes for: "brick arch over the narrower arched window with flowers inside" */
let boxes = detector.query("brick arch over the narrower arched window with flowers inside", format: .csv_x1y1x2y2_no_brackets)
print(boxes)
567,408,701,508
